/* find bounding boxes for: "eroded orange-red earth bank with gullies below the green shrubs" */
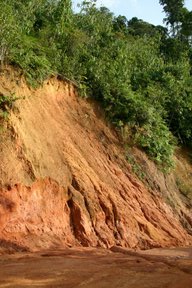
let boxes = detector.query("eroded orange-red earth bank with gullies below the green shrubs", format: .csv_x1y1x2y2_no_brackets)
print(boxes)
0,71,192,250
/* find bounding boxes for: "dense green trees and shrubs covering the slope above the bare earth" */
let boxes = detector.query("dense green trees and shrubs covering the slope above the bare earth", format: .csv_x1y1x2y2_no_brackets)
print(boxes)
0,0,192,169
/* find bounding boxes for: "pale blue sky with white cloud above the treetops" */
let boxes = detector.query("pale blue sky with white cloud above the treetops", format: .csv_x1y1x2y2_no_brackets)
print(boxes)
73,0,192,25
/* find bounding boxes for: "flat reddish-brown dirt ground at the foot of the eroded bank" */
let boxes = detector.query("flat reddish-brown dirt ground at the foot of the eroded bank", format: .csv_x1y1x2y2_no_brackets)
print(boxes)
0,247,192,288
